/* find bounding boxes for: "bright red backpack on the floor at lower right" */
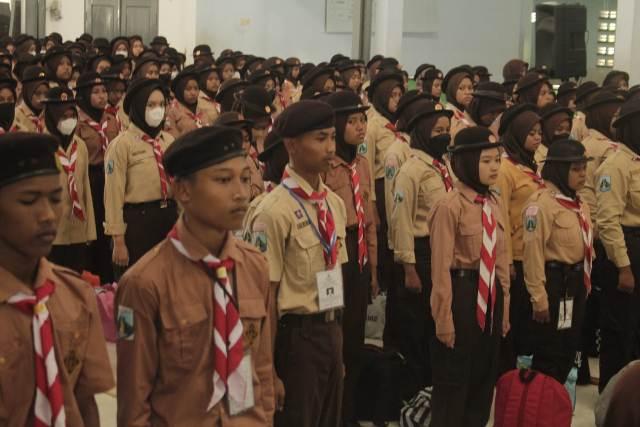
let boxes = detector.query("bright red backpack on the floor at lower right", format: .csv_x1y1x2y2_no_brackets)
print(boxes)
494,369,573,427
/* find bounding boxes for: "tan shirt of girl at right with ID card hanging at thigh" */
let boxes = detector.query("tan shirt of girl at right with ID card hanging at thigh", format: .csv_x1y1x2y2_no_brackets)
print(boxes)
522,181,591,311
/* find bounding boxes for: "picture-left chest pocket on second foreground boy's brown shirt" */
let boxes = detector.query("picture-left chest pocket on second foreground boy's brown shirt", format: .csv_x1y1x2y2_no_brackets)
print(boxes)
160,304,210,371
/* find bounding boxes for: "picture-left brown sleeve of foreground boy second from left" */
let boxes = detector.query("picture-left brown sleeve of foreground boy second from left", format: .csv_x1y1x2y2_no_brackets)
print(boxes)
114,275,159,427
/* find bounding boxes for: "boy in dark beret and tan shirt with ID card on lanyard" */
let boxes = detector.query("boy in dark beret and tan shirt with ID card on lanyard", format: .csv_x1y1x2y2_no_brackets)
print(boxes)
252,100,347,427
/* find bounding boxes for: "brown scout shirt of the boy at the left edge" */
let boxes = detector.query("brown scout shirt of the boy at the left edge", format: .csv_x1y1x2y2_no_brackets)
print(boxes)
0,258,115,427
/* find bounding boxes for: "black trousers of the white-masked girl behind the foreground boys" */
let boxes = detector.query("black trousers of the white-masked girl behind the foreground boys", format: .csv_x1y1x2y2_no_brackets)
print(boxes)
114,200,178,279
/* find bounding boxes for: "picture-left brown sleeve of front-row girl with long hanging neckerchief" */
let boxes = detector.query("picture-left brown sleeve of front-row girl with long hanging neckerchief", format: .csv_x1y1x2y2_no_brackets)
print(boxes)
429,196,460,334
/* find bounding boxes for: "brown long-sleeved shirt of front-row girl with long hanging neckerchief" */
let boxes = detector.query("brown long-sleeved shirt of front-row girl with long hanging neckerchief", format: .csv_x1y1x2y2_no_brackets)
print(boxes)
429,182,510,334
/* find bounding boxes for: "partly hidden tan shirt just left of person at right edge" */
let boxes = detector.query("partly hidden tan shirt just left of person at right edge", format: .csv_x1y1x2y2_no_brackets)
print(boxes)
578,129,618,235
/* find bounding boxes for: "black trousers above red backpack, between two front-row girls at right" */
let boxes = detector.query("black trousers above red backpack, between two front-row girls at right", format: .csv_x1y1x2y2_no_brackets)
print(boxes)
498,261,533,375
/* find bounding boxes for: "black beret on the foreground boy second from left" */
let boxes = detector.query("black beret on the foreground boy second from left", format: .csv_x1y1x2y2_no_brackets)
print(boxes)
163,126,245,177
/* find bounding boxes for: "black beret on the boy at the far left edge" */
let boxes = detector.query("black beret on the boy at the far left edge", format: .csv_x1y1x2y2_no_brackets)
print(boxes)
0,132,60,187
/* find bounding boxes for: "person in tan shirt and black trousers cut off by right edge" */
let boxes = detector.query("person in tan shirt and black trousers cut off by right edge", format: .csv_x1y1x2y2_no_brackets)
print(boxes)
595,100,640,391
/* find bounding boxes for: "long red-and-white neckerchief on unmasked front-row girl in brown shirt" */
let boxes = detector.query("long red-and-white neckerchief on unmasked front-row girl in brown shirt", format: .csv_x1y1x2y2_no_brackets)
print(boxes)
475,195,498,331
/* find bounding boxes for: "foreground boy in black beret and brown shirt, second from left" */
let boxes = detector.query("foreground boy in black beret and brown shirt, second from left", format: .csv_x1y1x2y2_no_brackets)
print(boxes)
116,126,275,427
